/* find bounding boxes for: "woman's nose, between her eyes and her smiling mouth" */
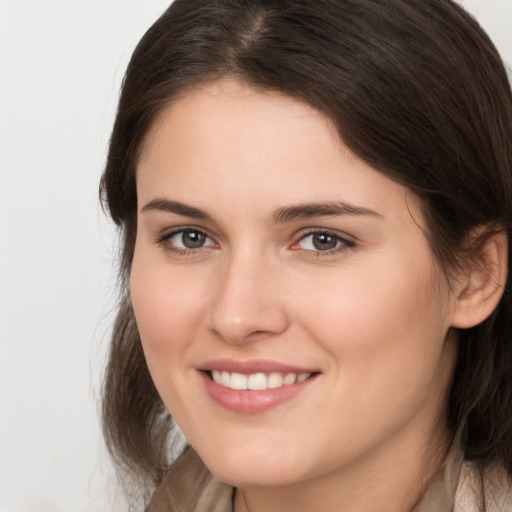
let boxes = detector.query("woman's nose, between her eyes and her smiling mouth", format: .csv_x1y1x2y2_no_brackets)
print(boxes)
209,255,288,345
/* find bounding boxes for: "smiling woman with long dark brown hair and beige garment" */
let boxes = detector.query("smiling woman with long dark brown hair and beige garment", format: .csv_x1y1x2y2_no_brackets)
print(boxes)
102,0,512,512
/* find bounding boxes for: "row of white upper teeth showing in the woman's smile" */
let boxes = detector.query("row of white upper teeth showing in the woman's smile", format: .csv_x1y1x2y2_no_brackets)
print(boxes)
212,370,311,391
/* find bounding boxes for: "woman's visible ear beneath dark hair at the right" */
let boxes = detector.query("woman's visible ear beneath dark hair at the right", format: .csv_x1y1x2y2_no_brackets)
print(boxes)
452,229,508,329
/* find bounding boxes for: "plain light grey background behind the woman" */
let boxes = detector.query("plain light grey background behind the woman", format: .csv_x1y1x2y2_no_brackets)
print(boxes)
0,0,512,512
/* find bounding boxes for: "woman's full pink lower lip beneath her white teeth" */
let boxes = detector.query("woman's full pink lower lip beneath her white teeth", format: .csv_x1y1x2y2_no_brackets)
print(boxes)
199,371,317,414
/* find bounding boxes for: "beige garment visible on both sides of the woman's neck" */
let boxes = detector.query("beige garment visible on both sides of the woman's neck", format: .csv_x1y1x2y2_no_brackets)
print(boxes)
146,442,512,512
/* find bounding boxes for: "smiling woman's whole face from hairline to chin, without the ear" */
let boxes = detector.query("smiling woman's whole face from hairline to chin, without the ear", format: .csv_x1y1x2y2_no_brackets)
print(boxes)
131,81,455,486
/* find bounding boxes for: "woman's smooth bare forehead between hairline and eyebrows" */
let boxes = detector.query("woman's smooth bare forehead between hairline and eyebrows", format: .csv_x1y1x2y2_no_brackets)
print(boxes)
137,80,421,224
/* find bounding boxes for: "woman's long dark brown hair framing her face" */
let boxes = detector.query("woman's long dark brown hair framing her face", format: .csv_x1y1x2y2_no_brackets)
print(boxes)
101,0,512,500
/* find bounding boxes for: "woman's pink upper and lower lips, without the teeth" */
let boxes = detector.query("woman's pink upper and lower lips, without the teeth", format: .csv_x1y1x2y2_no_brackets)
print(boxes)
198,359,319,415
